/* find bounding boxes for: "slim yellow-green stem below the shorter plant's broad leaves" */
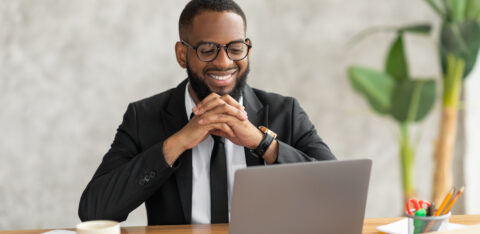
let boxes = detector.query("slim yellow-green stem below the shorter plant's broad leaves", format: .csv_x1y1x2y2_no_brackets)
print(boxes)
400,122,415,202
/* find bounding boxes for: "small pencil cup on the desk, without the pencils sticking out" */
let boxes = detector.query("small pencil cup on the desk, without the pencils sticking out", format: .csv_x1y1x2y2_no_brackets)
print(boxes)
406,212,451,234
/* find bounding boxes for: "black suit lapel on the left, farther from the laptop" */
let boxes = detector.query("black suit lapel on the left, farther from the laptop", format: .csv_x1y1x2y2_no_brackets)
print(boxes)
163,80,192,223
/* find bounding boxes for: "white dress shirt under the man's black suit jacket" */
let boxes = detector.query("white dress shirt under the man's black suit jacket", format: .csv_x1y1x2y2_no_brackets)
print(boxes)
185,83,247,224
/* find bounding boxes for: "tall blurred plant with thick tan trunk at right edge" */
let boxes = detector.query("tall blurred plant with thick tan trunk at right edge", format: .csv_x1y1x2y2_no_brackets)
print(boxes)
426,0,480,204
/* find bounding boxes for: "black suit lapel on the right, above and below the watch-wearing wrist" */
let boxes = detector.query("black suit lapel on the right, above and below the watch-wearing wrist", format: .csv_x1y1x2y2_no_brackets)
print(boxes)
243,85,268,167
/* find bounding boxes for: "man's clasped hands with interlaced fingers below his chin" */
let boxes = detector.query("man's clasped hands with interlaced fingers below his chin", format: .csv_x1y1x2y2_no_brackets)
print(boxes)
163,93,263,165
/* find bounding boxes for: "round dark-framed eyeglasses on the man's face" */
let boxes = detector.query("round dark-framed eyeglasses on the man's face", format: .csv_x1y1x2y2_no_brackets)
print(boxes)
181,38,252,62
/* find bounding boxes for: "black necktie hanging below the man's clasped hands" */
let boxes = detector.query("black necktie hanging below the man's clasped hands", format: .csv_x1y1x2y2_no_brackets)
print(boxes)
210,135,228,223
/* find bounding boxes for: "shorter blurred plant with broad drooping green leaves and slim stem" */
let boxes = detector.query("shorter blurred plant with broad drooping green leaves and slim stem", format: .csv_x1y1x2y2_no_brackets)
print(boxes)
348,25,436,201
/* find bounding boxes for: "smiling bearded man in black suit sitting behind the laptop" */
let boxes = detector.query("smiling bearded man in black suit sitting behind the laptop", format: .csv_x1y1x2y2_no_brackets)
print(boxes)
79,0,335,225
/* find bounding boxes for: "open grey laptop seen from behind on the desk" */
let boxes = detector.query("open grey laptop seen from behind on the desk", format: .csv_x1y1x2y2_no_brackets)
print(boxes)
229,159,372,234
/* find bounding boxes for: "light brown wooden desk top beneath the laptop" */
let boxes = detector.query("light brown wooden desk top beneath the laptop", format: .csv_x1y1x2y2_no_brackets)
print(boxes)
0,215,480,234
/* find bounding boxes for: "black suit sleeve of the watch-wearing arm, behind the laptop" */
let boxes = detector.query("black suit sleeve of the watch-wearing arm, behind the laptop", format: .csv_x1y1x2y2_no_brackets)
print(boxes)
276,99,336,163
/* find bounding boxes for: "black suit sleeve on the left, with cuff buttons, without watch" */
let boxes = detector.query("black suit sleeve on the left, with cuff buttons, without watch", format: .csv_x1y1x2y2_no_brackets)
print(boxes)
78,104,178,222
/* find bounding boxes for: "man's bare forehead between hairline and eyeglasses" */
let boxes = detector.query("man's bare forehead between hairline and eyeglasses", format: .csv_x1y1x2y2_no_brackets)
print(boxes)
190,11,245,44
